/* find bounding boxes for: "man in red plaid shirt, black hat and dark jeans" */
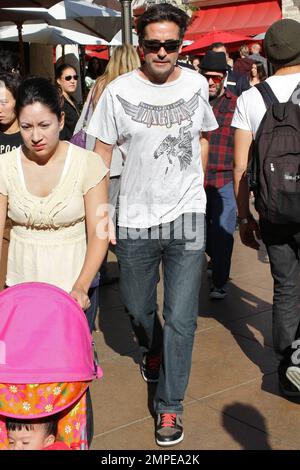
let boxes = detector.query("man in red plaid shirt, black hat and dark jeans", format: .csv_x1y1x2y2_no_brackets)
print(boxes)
201,51,237,299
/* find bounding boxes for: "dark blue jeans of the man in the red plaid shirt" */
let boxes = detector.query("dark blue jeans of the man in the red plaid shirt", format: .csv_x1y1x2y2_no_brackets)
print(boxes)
206,182,236,289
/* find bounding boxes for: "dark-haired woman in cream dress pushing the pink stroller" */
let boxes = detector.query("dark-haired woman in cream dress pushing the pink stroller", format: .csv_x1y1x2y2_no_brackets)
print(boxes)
0,78,108,309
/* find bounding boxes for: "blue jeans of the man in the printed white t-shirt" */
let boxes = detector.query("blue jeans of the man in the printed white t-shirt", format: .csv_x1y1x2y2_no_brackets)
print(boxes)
116,213,205,413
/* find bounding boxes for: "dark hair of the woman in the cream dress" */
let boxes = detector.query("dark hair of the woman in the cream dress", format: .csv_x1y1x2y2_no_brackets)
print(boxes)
16,77,62,119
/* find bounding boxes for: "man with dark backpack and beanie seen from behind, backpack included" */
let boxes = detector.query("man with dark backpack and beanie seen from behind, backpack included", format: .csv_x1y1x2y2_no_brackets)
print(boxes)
232,19,300,396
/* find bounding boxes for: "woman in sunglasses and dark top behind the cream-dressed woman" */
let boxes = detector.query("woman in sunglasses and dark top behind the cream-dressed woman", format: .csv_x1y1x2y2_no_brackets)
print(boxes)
55,64,79,140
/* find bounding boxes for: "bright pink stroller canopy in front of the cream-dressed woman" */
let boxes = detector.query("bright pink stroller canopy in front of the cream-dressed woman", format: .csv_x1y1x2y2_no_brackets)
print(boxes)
0,282,101,384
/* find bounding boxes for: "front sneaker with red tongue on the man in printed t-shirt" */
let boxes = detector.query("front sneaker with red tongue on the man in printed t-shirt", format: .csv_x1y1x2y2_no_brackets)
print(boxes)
155,413,184,446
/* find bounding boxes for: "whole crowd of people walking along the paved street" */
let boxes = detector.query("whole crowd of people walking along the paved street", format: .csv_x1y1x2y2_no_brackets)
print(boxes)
0,4,300,448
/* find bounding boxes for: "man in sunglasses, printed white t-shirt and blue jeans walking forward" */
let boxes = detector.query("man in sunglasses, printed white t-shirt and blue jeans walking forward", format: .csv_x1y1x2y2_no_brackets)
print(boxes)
88,4,218,446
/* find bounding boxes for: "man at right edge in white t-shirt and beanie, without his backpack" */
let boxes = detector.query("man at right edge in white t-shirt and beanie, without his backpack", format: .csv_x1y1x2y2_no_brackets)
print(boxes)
232,19,300,396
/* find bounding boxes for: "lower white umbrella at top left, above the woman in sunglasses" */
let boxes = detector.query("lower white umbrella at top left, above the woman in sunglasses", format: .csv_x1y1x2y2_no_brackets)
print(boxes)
0,23,108,45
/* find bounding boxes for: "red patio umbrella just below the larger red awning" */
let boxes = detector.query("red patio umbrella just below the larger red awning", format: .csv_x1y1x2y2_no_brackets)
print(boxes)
181,30,253,55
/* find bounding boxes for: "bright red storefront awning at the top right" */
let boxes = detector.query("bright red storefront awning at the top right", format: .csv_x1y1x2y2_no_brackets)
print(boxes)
185,0,282,40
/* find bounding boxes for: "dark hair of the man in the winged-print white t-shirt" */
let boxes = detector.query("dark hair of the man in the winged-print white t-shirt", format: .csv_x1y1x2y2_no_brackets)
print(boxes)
137,3,190,42
